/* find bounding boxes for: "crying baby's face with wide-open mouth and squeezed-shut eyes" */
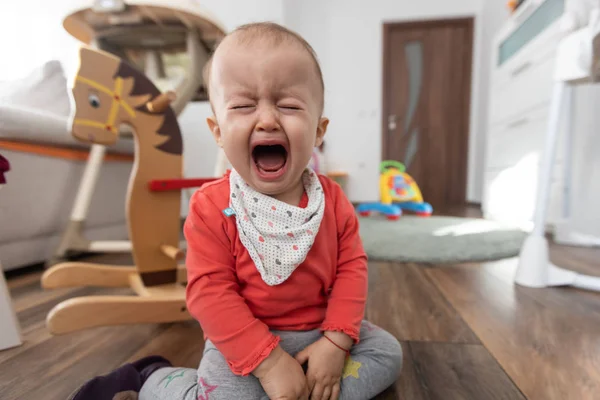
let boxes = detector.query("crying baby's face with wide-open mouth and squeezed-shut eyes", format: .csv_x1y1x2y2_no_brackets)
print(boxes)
209,39,328,196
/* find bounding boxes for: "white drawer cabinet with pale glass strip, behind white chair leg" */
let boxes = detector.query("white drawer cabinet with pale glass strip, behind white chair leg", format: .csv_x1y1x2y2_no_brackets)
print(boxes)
482,0,565,224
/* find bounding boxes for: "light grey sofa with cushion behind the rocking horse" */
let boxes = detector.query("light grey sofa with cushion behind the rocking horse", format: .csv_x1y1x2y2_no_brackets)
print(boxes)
0,61,133,270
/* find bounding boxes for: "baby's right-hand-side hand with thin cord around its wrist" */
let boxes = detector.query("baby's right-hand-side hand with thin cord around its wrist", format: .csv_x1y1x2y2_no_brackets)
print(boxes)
296,332,352,400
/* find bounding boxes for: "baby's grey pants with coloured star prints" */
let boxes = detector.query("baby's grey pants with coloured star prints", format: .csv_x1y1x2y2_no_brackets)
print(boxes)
139,321,402,400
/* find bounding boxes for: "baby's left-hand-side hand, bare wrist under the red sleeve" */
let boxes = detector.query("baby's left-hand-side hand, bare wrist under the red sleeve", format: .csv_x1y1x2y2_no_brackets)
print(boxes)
252,346,308,400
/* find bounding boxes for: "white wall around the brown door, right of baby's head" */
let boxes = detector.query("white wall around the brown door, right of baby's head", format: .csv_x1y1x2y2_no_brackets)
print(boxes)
284,0,482,202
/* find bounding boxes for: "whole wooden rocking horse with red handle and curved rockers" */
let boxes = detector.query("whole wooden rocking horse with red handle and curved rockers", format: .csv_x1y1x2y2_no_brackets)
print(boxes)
42,47,212,334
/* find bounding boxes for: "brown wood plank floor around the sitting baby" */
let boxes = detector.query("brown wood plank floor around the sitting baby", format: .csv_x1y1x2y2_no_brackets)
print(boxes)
0,209,600,400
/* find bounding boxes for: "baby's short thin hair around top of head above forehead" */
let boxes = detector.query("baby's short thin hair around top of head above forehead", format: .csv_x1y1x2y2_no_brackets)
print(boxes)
203,22,325,112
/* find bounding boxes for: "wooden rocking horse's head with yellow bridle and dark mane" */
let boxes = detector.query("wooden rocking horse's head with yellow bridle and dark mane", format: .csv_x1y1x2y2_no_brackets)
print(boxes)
71,46,182,154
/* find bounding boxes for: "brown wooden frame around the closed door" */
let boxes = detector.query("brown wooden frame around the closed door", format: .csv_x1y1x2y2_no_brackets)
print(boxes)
381,17,475,204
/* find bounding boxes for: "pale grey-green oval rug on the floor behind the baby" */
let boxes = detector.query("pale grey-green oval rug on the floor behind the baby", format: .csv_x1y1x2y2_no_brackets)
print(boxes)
359,215,527,264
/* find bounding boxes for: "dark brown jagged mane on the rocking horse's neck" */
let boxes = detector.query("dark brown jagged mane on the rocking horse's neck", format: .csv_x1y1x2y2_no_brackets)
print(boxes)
113,60,183,154
